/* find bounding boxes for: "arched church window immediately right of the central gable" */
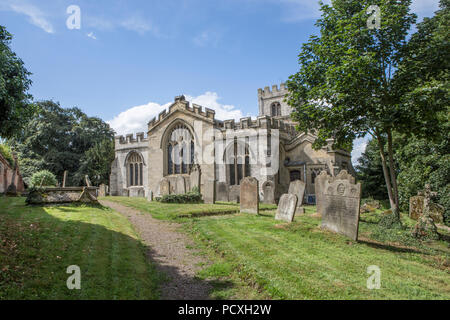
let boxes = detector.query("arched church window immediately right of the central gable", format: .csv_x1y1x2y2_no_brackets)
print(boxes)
225,139,251,186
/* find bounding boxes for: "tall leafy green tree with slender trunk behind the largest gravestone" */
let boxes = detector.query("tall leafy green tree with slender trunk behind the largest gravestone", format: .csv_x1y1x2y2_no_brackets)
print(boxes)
287,0,440,222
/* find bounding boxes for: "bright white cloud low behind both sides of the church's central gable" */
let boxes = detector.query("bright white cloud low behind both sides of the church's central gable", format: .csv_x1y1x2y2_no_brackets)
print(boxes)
107,92,243,135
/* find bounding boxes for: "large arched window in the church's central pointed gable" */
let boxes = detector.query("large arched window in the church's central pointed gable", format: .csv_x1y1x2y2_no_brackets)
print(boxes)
166,123,195,174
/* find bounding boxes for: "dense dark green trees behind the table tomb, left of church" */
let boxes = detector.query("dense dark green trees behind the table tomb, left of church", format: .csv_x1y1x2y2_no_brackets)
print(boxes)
8,101,114,186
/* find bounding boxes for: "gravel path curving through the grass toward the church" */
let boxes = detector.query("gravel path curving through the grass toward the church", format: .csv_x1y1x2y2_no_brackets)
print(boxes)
100,200,211,300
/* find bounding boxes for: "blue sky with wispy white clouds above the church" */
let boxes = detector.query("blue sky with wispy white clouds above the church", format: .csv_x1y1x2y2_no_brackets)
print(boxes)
0,0,438,160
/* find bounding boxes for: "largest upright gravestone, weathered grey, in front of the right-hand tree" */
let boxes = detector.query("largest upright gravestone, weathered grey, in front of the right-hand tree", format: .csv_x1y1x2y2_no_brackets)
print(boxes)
322,179,361,240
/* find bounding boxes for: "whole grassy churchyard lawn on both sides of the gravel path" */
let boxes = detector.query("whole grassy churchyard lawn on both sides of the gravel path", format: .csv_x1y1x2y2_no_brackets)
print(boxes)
0,197,450,299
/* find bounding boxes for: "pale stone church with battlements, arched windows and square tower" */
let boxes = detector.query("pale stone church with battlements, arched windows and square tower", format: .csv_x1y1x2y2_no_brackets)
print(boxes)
110,84,354,203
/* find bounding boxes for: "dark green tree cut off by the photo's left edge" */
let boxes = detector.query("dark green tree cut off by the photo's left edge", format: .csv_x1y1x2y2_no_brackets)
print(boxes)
0,26,35,138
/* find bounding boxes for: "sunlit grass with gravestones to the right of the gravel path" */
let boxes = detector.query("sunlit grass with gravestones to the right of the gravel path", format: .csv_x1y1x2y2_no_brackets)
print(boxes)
108,198,450,299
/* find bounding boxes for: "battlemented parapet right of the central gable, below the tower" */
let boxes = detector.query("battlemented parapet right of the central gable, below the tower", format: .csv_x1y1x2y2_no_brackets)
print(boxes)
216,116,298,136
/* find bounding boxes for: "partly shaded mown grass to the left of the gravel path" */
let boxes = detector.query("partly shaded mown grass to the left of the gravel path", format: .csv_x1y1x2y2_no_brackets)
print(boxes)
0,197,162,300
